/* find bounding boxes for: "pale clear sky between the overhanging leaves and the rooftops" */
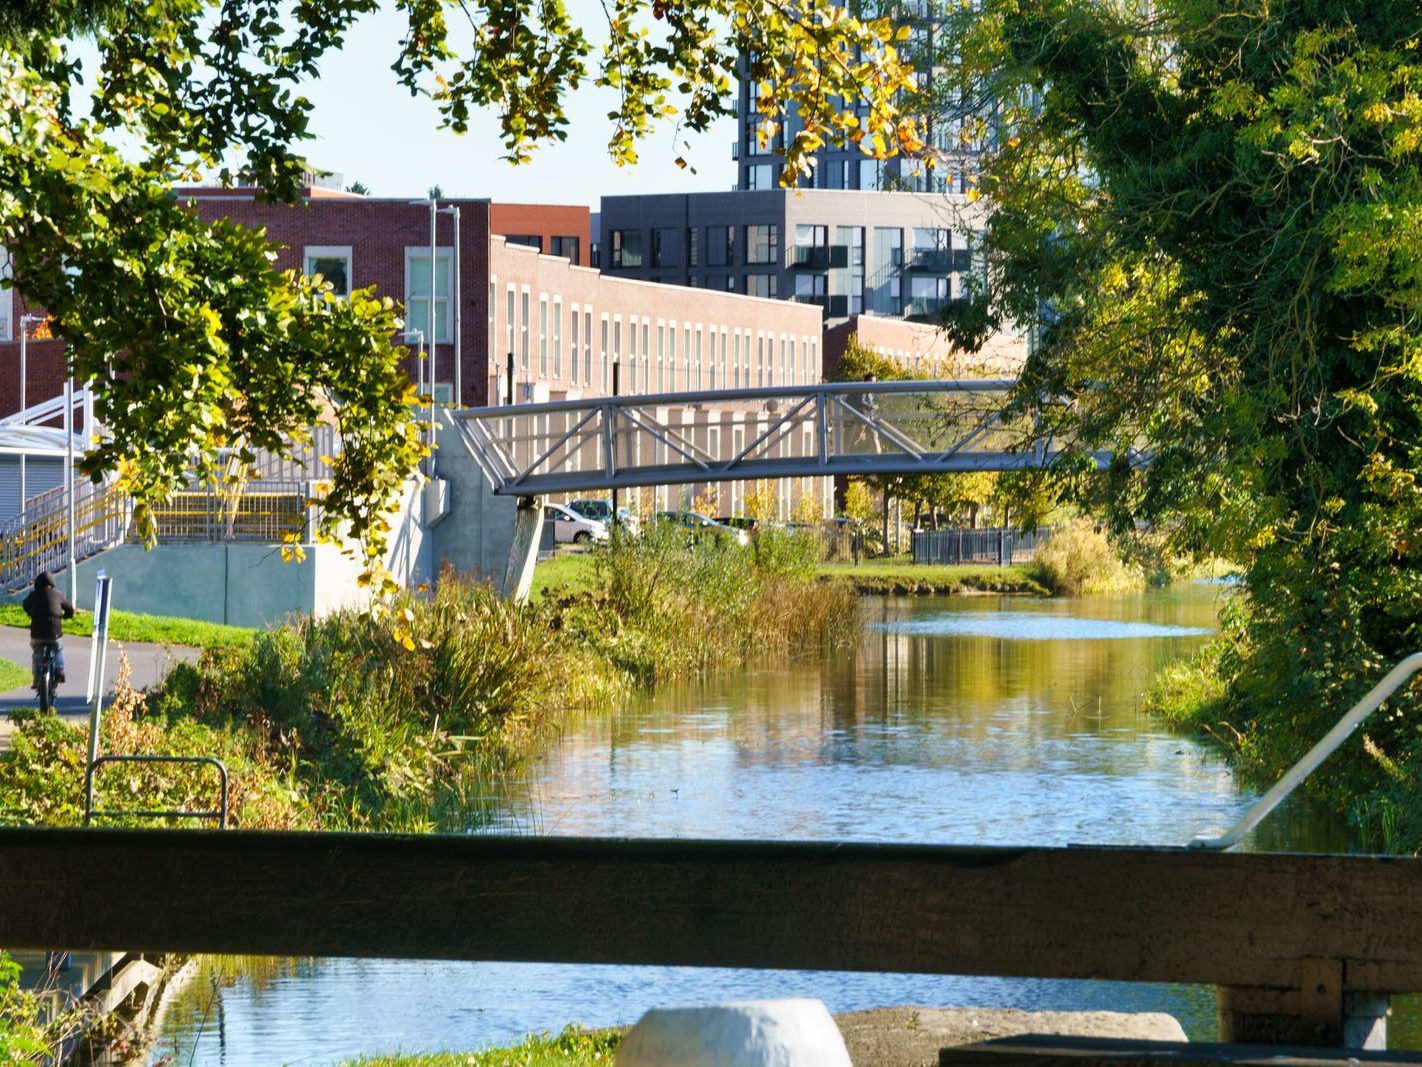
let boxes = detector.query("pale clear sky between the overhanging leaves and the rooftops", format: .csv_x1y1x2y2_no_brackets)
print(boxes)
295,0,735,204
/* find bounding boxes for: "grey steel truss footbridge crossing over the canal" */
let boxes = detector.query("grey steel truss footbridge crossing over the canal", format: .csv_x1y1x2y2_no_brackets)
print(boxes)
456,380,1111,497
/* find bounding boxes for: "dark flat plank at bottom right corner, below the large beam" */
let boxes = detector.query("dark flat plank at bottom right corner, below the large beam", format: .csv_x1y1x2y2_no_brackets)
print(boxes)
939,1034,1422,1067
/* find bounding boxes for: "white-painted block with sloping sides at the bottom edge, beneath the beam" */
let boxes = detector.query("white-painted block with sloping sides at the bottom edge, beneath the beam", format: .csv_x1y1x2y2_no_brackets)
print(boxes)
616,999,850,1067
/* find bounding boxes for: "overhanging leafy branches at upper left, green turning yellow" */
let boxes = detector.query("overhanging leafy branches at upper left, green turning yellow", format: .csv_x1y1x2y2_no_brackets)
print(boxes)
0,0,916,577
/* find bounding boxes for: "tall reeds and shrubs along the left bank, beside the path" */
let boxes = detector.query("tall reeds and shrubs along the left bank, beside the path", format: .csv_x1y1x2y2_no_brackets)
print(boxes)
0,526,857,831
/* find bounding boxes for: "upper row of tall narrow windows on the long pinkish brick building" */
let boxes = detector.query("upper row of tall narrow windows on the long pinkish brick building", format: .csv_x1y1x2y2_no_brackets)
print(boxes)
489,280,819,393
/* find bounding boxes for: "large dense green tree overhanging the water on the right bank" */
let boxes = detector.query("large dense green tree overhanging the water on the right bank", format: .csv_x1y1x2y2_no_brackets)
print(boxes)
954,0,1422,846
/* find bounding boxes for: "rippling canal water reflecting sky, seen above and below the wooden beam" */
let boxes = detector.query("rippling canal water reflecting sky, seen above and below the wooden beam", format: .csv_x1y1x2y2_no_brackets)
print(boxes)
158,583,1387,1067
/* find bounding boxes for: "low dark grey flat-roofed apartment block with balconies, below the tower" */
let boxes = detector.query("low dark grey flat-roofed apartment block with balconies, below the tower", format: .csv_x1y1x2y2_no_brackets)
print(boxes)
599,189,977,320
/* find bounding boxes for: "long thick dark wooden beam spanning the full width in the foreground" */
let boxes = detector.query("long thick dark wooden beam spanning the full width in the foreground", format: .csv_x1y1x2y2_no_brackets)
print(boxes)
0,829,1422,993
